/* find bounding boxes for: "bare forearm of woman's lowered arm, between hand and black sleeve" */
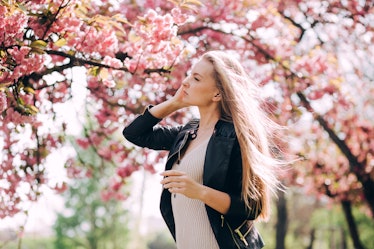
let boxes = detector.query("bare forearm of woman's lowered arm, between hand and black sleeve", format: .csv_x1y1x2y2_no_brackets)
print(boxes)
199,186,231,214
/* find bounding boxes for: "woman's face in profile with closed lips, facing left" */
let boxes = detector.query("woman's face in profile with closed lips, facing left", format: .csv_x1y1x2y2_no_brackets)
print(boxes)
182,59,219,106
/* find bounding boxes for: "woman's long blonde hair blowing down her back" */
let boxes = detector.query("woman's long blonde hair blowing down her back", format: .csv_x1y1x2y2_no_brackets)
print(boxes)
202,51,282,221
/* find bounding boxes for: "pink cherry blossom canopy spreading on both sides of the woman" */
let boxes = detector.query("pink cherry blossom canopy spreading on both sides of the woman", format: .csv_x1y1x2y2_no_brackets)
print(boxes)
0,0,374,224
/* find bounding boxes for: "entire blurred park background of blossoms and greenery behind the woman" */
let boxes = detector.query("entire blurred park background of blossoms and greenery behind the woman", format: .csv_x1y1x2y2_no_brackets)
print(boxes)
0,0,374,249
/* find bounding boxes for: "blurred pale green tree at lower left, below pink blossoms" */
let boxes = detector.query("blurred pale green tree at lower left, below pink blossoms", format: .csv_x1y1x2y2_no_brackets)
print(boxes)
54,134,128,249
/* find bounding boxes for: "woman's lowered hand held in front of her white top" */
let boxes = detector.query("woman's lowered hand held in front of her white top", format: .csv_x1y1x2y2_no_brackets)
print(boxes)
161,170,205,199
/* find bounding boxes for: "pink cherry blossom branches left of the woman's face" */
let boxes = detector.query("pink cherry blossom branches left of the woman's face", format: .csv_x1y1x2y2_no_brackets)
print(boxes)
0,0,190,218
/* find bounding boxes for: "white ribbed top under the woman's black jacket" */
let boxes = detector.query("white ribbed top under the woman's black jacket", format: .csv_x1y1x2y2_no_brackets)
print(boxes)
171,139,219,249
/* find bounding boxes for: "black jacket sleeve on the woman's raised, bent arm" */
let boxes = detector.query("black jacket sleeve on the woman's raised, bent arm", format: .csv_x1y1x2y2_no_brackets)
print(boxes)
122,106,180,150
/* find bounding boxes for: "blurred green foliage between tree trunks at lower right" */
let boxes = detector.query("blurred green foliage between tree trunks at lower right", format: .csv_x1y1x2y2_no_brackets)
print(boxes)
257,193,374,249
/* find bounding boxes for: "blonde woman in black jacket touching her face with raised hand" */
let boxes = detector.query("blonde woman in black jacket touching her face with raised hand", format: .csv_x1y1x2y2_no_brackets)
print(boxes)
123,51,280,249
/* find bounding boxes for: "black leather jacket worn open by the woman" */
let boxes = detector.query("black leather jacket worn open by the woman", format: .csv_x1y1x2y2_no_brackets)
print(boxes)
123,106,264,249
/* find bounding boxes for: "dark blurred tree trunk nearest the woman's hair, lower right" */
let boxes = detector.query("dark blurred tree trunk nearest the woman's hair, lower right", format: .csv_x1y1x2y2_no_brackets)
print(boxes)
275,191,288,249
